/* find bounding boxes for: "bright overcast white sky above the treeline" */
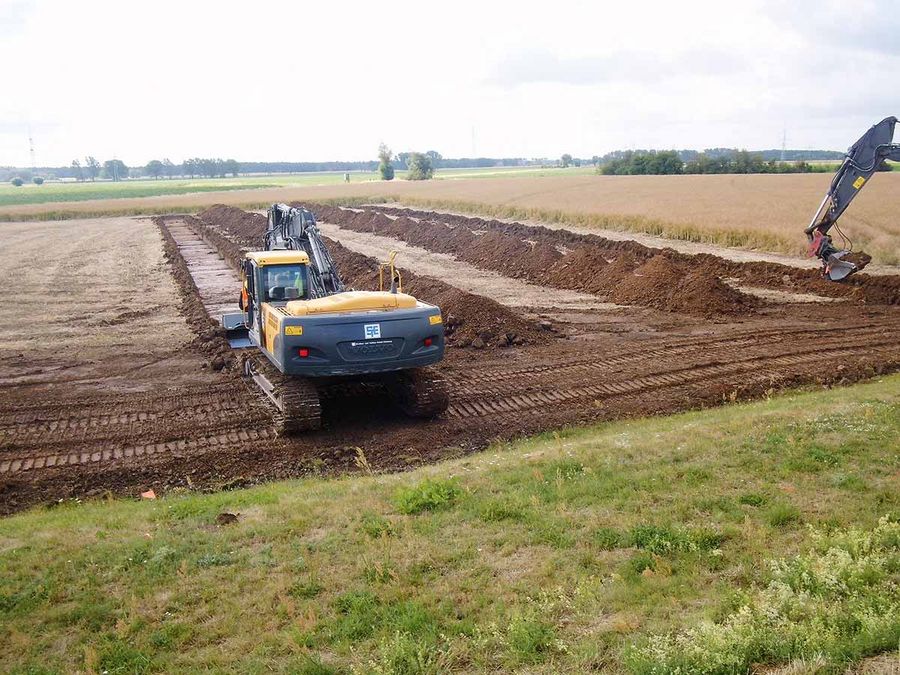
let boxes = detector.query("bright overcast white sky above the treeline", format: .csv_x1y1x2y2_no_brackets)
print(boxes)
0,0,900,166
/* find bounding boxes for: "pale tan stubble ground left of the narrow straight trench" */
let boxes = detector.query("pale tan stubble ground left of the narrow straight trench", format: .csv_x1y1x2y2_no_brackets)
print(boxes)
0,218,200,396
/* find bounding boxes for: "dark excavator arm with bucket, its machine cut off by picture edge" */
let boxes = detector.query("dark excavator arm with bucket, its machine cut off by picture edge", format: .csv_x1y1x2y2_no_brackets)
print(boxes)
805,117,900,281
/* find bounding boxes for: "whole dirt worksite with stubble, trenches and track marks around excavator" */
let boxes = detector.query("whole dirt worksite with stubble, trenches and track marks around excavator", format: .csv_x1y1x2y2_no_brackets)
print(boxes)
0,207,900,512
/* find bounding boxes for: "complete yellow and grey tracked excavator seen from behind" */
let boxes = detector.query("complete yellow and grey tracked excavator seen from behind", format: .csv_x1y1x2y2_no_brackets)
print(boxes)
222,204,449,434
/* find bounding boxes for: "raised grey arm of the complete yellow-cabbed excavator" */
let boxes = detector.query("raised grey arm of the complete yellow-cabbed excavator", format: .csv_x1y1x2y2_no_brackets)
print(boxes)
263,204,344,298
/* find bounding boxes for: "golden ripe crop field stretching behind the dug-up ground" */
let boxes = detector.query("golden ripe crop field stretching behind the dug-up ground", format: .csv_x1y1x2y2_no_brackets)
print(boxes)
0,172,900,264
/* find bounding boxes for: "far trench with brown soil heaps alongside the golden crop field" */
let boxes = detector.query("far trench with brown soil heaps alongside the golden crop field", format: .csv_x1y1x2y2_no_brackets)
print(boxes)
307,204,900,316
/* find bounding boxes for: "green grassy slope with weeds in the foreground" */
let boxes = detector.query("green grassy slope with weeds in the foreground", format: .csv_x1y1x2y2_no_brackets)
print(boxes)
0,375,900,673
